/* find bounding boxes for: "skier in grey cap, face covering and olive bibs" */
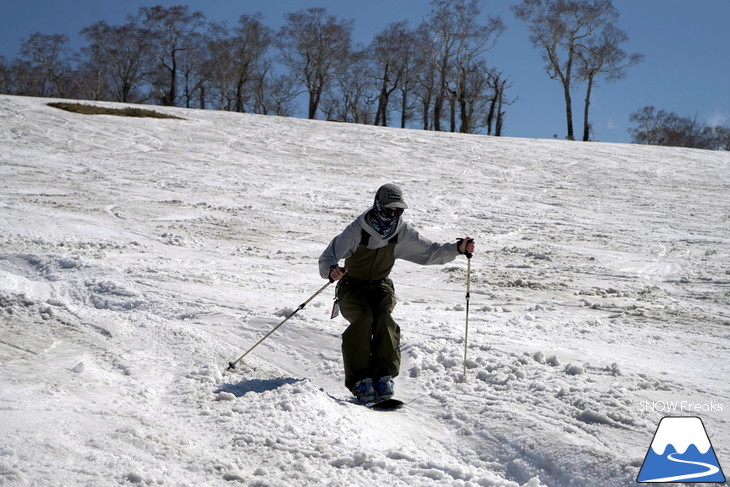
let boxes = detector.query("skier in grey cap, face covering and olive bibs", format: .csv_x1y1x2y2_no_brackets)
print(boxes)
319,184,474,402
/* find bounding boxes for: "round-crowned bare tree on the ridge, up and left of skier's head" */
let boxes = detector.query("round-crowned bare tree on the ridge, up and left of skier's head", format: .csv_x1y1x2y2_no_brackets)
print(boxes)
279,8,353,119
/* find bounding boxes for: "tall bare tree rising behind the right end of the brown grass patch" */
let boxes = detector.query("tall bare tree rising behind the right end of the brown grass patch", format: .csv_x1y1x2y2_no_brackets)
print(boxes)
139,5,205,106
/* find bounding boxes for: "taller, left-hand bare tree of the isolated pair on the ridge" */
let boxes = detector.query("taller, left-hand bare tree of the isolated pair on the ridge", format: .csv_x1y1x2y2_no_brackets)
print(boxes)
511,0,618,140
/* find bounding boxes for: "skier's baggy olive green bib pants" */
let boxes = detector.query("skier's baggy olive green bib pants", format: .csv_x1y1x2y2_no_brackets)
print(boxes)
337,232,401,390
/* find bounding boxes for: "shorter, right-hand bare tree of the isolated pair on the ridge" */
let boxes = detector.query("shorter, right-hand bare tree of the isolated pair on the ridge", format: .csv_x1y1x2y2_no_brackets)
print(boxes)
576,24,644,141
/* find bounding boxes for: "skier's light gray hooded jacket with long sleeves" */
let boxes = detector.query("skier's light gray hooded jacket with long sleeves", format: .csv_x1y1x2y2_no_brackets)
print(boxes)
319,210,459,279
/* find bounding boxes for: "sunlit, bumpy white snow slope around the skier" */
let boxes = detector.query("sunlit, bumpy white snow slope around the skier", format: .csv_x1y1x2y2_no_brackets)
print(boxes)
0,96,730,487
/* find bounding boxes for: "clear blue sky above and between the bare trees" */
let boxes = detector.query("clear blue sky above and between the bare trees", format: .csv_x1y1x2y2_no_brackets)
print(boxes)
0,0,730,142
